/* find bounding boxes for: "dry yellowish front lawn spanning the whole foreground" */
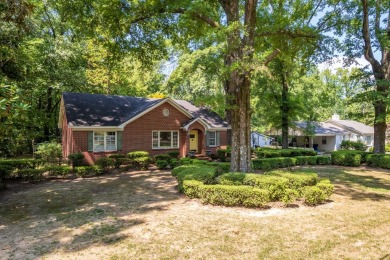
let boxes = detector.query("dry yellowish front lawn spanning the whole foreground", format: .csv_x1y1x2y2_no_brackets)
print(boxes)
0,166,390,259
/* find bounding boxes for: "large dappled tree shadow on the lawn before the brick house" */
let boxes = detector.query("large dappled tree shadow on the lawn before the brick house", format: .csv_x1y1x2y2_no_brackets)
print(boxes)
0,172,181,258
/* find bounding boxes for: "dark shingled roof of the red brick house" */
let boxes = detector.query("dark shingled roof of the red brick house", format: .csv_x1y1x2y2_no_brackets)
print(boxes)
63,92,229,128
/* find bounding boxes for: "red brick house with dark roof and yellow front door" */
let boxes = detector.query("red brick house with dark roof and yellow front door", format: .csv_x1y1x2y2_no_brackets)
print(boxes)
58,92,230,164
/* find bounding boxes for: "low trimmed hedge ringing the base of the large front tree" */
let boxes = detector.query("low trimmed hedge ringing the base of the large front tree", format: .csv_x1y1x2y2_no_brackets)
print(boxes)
172,164,333,207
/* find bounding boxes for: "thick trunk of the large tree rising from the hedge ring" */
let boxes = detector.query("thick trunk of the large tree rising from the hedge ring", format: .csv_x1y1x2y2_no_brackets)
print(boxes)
220,0,257,172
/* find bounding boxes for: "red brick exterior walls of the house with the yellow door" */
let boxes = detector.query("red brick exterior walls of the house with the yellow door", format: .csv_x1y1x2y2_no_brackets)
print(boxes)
62,100,227,164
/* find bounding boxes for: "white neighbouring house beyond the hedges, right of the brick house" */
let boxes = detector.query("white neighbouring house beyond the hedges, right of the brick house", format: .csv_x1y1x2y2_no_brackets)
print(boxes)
290,115,374,152
